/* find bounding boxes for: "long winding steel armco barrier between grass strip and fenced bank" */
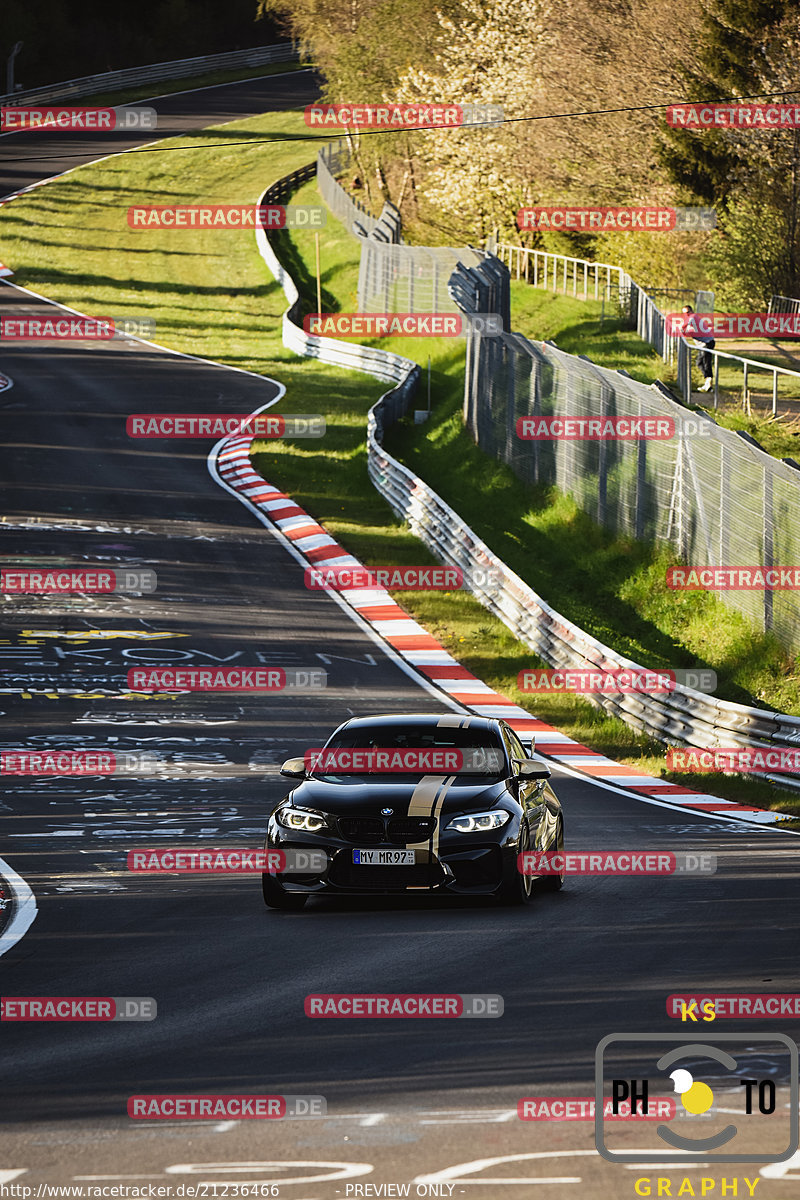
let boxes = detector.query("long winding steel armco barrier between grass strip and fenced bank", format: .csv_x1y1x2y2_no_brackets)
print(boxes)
255,164,800,786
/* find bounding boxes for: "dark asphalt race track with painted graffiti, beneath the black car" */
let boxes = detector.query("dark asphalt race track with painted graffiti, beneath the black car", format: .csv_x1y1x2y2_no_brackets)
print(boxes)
0,73,800,1200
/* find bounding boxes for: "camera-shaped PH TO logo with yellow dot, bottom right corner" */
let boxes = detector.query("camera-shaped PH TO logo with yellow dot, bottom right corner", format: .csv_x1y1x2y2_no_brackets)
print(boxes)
595,1033,799,1165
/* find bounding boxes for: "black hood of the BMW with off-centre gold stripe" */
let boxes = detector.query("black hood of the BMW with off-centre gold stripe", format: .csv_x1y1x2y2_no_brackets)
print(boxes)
288,775,511,817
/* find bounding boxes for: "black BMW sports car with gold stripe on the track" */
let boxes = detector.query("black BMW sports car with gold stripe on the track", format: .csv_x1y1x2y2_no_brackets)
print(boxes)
261,713,564,910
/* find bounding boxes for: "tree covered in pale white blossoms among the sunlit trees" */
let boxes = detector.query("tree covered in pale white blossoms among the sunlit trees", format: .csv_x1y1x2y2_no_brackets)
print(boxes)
391,0,551,242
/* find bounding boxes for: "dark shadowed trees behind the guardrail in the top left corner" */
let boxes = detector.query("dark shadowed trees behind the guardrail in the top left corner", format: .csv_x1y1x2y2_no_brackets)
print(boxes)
0,0,278,92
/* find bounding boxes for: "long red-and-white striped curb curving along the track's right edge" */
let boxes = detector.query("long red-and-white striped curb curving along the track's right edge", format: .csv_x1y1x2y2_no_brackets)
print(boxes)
215,436,789,824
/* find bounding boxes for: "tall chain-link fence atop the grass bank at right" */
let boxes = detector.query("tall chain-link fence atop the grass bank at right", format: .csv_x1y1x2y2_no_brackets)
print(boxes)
452,264,800,667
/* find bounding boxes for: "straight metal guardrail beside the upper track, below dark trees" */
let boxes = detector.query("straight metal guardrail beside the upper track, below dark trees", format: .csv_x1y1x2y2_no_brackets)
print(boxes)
0,42,299,106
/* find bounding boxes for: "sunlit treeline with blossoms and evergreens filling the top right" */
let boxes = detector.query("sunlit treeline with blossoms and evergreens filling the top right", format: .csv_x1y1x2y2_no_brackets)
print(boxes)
259,0,800,308
